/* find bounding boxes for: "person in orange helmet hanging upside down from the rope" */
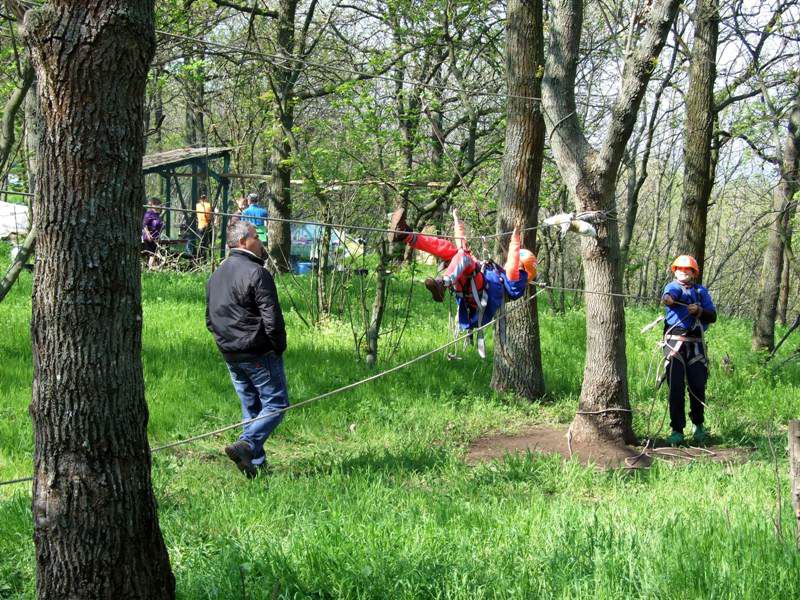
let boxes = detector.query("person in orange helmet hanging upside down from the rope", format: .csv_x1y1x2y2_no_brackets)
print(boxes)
388,208,536,357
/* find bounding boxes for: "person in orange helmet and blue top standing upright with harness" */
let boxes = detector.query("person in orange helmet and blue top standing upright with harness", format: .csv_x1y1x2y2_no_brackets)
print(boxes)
661,255,717,446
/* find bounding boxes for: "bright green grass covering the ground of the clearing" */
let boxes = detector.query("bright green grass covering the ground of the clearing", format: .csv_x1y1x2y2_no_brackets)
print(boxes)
0,251,800,600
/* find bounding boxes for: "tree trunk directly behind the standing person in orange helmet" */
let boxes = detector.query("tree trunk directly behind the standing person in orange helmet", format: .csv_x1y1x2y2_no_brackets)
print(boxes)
677,0,719,275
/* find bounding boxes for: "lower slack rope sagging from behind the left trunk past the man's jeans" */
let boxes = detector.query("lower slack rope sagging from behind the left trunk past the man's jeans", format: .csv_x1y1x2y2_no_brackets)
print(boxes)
0,288,544,487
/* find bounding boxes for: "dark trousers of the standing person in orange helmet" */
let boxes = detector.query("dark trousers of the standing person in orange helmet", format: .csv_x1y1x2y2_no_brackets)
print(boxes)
666,342,708,432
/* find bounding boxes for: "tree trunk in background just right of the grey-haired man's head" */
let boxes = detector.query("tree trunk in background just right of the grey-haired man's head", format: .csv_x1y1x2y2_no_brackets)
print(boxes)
267,0,297,271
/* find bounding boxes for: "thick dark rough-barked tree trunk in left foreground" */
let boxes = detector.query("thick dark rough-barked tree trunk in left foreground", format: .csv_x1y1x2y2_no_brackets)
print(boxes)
25,0,175,599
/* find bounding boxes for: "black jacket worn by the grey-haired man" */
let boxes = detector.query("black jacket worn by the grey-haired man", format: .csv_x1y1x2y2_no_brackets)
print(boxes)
206,249,286,361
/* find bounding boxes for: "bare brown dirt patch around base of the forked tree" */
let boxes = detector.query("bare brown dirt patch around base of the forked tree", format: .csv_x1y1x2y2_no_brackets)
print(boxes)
466,425,750,469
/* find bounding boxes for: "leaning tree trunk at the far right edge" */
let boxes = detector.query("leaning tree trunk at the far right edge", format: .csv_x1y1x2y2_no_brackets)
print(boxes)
752,100,800,350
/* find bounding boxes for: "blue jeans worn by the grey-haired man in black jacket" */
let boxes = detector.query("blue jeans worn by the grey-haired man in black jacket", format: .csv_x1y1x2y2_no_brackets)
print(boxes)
226,352,289,465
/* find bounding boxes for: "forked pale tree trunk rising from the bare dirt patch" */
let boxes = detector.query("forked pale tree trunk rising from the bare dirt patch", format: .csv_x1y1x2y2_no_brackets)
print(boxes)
542,0,680,443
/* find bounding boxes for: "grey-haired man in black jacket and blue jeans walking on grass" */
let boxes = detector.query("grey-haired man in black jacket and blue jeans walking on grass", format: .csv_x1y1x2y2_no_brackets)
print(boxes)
206,221,289,479
